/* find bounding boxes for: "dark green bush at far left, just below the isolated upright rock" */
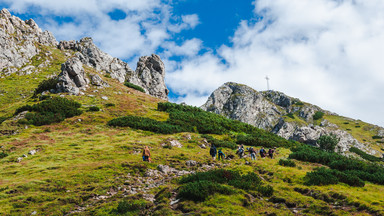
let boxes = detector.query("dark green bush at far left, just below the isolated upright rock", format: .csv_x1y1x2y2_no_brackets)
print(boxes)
15,97,82,126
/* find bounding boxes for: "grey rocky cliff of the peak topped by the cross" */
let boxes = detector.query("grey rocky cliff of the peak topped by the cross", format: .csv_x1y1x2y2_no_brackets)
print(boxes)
201,82,381,154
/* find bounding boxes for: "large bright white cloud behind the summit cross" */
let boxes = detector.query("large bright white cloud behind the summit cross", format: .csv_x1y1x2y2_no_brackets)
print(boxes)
168,0,384,126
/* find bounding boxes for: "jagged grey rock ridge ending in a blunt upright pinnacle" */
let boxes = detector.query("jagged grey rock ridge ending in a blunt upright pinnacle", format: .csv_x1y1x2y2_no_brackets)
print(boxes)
58,38,168,100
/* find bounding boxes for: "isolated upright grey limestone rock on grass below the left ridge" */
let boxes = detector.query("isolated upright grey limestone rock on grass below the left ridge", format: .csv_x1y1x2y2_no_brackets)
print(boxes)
56,57,89,95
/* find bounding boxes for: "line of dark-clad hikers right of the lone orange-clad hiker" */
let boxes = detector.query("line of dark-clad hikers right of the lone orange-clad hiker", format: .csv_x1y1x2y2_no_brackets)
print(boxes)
209,144,276,160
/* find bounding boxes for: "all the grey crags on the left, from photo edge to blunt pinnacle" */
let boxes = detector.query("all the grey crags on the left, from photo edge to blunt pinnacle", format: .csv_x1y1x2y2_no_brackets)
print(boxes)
0,9,168,100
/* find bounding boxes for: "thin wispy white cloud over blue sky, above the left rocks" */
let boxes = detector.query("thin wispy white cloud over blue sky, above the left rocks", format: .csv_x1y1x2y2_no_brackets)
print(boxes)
4,0,198,62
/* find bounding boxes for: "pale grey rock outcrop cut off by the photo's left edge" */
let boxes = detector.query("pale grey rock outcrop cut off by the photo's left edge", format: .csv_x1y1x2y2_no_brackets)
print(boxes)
0,9,57,76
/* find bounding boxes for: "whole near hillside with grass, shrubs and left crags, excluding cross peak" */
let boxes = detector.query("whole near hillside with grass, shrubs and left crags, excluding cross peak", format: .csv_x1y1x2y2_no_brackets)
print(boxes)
0,7,384,215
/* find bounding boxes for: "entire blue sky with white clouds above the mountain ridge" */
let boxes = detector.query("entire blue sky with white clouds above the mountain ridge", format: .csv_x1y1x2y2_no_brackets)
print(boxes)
0,0,384,126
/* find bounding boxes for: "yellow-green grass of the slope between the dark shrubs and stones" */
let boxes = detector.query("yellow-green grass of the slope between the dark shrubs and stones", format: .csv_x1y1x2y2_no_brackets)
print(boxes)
0,46,384,215
